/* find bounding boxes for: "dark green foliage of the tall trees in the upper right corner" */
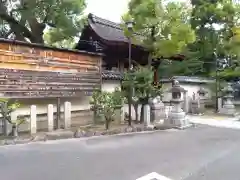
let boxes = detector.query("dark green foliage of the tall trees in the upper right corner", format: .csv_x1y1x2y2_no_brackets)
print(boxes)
188,0,240,75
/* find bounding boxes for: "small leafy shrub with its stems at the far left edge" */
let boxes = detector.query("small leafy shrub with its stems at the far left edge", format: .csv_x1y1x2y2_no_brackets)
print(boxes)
0,99,25,137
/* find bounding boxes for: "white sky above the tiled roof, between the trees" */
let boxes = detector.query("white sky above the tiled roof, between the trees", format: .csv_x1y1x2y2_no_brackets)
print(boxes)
86,0,129,22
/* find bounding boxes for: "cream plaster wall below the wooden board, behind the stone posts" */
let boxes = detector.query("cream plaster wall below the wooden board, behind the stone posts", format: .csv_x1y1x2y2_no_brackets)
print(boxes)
0,96,92,133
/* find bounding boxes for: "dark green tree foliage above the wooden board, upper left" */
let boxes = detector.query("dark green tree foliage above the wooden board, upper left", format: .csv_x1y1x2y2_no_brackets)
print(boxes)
0,0,85,44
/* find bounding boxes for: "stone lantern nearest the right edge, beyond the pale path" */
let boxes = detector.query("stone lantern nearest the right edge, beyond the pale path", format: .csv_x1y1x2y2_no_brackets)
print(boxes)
220,83,236,116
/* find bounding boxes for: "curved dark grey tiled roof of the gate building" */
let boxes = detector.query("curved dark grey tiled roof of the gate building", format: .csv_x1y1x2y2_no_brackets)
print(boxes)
88,14,140,42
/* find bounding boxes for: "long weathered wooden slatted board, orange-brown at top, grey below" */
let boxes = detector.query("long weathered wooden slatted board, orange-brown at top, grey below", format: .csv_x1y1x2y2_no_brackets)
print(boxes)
0,42,101,98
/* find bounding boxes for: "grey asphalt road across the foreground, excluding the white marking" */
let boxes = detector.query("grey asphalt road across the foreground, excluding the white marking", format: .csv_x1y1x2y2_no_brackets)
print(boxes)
0,126,240,180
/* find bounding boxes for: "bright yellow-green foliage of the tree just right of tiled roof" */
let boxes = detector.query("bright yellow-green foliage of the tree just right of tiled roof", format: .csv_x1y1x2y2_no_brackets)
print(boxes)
123,0,195,57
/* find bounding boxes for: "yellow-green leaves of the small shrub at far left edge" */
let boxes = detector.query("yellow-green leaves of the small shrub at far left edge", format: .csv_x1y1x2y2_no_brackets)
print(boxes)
0,98,25,126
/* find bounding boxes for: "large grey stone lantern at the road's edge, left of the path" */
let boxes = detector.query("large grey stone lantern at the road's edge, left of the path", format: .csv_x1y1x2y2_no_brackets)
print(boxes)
165,81,189,128
